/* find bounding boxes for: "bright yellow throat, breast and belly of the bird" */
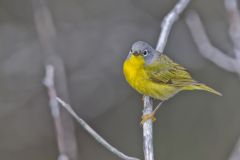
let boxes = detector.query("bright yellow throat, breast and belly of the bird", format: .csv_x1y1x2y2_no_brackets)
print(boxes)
123,56,179,100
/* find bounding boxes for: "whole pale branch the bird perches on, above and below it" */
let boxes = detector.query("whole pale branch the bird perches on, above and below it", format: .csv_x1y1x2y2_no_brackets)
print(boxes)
143,0,190,160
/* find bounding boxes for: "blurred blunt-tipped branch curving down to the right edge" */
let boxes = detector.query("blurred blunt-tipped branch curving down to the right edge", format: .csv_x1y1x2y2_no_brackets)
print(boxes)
186,11,239,72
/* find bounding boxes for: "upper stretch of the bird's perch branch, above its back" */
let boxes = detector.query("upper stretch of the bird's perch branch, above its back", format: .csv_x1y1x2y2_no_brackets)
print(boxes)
156,0,190,53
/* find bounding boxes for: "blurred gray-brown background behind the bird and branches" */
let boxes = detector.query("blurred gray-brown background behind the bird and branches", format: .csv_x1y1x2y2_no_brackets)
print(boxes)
0,0,240,160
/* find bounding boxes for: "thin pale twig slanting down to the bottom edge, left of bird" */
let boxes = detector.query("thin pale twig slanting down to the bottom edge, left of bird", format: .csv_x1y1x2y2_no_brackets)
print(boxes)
56,97,139,160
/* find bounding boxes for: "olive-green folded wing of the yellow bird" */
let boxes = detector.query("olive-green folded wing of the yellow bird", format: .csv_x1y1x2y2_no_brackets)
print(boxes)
145,54,195,87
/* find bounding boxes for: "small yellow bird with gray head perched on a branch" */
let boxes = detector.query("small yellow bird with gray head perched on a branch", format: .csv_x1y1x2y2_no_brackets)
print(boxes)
123,41,222,124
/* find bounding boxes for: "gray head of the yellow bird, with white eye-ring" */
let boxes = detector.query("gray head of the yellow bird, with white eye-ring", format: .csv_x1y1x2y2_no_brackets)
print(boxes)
128,41,158,64
